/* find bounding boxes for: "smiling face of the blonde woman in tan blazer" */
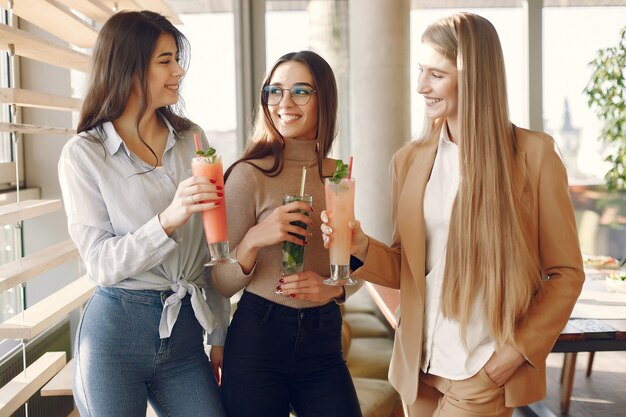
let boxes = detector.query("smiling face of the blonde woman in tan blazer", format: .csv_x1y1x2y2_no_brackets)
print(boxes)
417,43,459,130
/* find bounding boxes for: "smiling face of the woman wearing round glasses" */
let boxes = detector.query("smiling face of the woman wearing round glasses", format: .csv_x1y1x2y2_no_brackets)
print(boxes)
267,61,318,140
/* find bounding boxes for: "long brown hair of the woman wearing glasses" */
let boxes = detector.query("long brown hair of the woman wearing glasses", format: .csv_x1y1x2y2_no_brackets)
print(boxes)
225,51,337,178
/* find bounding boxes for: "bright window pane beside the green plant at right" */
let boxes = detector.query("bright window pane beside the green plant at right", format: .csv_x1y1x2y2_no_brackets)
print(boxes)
543,7,626,184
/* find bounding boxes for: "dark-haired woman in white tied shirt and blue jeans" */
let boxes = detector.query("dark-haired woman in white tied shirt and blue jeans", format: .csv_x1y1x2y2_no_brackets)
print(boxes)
59,11,230,417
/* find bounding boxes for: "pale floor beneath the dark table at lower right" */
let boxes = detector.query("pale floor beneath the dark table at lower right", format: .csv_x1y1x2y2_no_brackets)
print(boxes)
513,352,626,417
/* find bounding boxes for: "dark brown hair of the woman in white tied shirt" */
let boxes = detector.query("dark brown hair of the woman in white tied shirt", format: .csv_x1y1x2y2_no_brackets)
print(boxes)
77,11,191,156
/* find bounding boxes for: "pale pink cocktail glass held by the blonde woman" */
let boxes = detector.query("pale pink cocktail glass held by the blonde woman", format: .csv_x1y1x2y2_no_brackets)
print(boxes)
324,179,356,285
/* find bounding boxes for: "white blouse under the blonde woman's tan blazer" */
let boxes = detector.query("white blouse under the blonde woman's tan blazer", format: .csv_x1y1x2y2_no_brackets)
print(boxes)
421,126,495,380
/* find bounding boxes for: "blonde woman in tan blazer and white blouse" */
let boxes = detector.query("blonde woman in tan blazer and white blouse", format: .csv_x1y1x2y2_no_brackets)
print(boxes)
321,13,584,417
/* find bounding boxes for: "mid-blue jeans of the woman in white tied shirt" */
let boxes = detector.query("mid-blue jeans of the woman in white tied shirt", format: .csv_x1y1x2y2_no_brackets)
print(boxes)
73,287,225,417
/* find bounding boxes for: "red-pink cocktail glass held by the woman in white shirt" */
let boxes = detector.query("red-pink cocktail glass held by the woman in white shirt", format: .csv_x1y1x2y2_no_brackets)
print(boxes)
191,156,235,265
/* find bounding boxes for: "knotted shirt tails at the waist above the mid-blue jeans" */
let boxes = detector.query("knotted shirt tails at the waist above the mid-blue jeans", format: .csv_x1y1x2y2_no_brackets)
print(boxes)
159,279,215,339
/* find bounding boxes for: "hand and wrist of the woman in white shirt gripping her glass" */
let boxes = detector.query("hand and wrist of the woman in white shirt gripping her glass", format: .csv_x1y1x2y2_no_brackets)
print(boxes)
159,177,223,236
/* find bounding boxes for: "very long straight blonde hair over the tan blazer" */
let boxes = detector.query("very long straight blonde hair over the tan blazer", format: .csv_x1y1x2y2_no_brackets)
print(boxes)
422,13,542,346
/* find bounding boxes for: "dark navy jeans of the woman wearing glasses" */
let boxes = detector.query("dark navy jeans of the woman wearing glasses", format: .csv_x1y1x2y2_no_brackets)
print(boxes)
221,292,361,417
